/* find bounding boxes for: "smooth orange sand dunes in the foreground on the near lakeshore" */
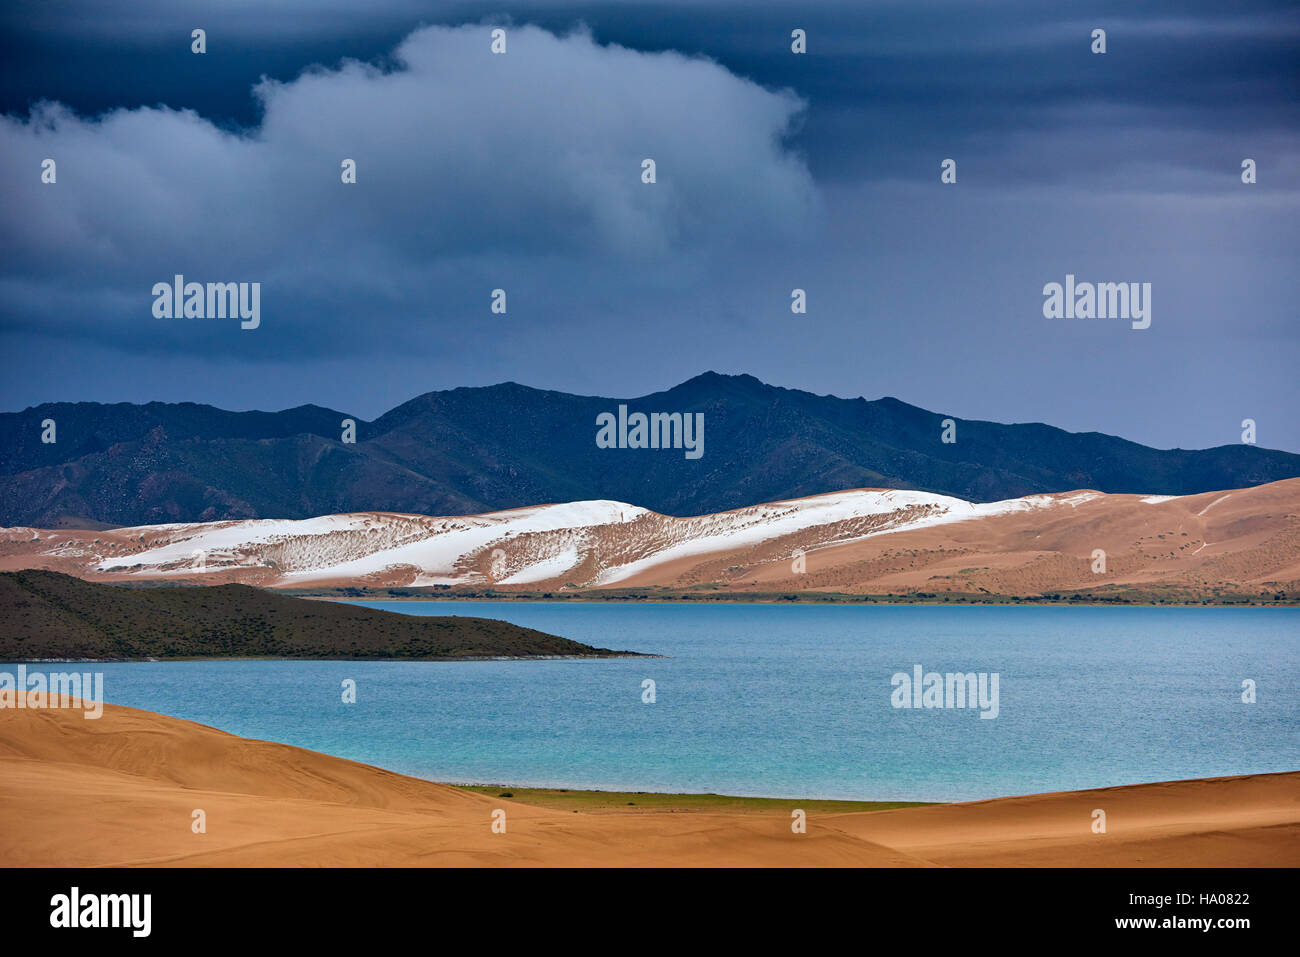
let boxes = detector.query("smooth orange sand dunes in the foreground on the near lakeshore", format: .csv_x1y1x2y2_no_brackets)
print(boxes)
0,705,1300,866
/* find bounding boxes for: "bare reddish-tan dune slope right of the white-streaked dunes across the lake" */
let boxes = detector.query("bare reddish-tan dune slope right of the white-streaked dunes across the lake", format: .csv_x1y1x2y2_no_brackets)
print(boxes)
613,479,1300,598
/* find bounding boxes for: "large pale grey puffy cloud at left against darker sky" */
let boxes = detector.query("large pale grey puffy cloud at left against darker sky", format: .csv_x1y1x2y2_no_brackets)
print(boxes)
0,27,818,355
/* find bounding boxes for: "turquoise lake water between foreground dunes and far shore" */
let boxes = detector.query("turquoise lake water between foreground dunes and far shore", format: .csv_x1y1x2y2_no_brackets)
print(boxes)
25,602,1300,801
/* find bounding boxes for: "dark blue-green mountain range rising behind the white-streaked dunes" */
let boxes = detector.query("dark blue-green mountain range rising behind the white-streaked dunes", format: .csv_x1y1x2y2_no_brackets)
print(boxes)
0,373,1300,528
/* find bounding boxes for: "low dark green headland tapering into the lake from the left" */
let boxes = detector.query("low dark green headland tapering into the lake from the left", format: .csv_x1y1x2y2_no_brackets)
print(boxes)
0,571,629,661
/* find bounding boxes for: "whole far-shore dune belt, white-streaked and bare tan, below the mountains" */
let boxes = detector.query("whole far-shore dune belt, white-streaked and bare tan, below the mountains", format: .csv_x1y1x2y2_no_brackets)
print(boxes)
0,479,1300,601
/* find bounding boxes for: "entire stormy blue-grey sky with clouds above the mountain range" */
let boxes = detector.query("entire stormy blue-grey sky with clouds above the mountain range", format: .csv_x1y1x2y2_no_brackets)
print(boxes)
0,0,1300,451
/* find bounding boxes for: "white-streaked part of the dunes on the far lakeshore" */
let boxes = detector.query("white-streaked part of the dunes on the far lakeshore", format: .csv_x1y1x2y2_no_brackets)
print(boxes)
0,490,1095,586
